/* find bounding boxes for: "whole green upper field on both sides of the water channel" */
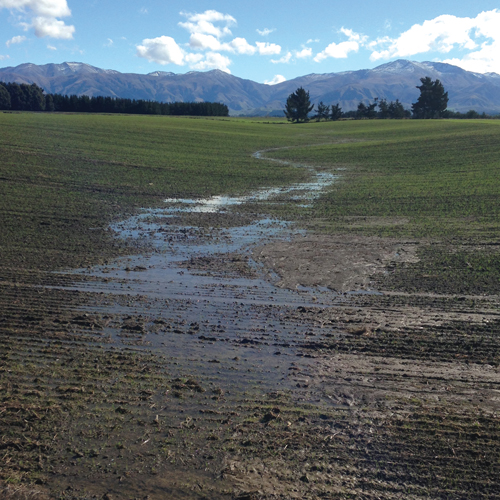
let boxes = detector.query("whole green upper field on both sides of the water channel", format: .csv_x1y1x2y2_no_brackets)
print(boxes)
0,113,500,276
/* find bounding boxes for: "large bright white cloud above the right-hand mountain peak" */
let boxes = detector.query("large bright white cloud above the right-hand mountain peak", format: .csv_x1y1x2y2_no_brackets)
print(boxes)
369,9,500,71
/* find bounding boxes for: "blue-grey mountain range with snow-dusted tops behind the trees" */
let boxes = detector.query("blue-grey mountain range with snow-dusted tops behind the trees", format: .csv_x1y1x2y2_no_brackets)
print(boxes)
0,60,500,116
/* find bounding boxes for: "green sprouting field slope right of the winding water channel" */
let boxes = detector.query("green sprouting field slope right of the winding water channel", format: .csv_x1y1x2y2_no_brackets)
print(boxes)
270,120,500,238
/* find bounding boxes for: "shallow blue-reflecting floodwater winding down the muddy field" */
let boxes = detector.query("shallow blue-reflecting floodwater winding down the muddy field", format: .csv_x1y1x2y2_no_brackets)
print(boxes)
62,152,342,402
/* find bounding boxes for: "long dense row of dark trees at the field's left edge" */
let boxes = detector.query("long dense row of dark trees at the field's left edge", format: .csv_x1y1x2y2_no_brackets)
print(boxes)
0,82,229,116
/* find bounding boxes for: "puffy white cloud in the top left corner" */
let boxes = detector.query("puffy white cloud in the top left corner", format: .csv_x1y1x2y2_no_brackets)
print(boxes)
0,0,75,39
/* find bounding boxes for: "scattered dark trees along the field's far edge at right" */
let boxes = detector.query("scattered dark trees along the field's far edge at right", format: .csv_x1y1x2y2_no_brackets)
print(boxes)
284,76,500,122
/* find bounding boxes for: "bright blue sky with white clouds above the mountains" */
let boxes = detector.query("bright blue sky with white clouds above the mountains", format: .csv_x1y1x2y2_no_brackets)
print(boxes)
0,0,500,85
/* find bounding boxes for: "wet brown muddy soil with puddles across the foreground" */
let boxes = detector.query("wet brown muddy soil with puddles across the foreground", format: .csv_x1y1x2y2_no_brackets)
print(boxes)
0,149,500,500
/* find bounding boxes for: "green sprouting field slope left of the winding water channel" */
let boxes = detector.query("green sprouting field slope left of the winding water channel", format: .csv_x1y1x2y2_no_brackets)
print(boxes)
0,113,309,268
